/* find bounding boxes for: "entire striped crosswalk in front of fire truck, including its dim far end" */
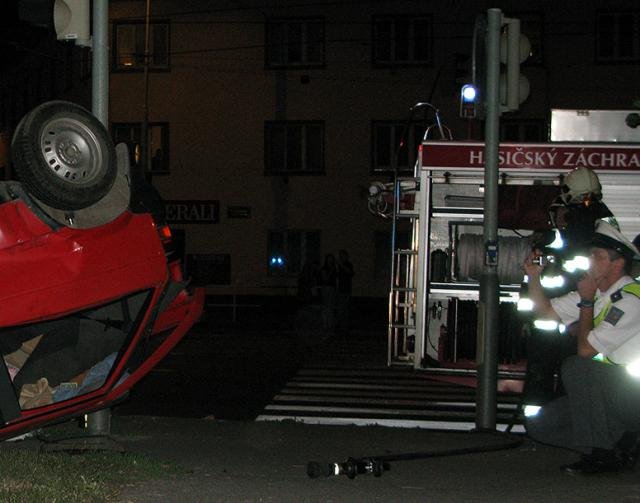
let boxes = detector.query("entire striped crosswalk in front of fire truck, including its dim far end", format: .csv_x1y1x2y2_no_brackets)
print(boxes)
256,333,523,432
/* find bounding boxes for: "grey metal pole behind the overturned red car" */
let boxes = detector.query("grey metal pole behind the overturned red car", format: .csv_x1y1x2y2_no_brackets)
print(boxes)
87,0,111,435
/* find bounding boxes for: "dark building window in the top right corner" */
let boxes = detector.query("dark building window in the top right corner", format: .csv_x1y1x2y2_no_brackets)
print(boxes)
594,9,640,65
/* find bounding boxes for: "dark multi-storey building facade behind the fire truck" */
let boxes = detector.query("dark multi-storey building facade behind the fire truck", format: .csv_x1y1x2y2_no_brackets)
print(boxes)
3,0,640,297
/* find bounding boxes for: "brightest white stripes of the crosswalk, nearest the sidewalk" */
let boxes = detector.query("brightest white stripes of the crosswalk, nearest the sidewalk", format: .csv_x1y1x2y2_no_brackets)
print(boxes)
257,368,524,432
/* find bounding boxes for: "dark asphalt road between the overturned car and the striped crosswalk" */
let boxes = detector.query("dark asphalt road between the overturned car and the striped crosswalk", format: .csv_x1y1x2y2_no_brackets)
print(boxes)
113,299,387,420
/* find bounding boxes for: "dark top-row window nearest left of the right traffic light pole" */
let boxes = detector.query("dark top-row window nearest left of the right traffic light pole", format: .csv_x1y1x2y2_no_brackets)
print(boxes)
371,13,433,68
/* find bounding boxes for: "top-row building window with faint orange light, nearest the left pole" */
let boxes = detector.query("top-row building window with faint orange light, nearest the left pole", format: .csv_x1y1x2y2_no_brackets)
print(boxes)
111,20,171,73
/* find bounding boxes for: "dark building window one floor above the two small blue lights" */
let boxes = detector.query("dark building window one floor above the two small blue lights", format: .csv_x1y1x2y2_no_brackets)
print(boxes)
264,120,325,176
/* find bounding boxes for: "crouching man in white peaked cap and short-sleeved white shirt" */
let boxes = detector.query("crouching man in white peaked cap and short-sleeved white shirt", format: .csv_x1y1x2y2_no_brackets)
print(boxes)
523,221,640,474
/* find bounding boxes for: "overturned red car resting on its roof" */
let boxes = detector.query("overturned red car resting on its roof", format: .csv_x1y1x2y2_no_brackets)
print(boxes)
0,101,204,439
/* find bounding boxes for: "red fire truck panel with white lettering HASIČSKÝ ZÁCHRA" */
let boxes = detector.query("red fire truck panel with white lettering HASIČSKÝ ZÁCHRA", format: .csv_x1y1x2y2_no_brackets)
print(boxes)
422,141,640,172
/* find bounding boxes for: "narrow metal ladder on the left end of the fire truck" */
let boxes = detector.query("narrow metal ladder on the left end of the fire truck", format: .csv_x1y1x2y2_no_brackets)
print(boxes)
387,176,420,365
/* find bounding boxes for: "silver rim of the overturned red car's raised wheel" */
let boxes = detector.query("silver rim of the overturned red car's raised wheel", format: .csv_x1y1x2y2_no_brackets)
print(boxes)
40,117,103,185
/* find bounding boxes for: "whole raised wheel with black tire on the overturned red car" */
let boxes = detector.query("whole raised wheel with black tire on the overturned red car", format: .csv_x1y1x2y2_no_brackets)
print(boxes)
11,101,117,210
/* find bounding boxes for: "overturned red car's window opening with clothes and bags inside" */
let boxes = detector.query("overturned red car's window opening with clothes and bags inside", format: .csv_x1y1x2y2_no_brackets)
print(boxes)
0,291,149,410
